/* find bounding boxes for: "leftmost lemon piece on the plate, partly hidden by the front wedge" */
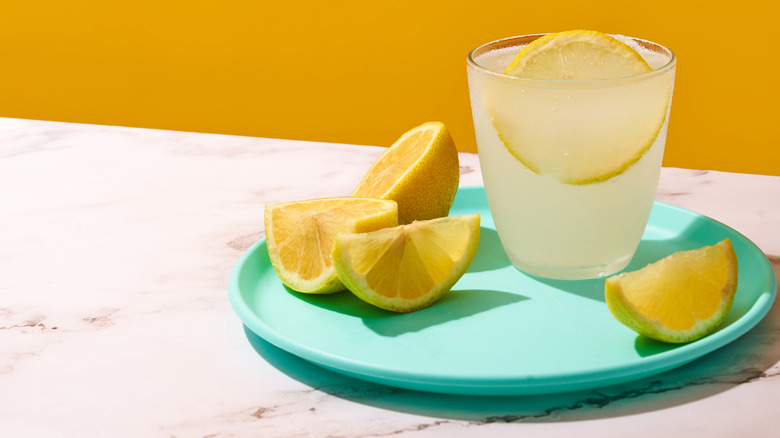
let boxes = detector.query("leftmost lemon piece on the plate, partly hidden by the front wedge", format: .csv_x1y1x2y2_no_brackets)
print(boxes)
265,197,398,294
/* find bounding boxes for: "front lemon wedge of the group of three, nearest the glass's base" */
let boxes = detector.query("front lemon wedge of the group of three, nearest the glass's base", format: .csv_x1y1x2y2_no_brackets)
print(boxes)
333,214,480,312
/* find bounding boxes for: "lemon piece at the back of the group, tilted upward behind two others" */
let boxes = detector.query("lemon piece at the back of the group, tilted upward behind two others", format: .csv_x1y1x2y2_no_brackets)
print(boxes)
352,122,460,224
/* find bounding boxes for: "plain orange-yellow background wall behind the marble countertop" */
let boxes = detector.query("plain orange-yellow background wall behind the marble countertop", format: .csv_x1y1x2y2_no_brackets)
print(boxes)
0,0,780,175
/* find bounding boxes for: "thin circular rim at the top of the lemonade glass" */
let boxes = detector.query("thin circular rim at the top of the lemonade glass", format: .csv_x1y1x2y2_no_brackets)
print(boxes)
466,32,677,85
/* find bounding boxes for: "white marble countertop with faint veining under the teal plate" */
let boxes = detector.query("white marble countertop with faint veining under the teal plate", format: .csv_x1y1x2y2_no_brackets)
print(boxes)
0,119,780,437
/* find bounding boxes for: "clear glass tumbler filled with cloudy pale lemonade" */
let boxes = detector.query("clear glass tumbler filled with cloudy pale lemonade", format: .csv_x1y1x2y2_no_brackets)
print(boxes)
467,35,676,279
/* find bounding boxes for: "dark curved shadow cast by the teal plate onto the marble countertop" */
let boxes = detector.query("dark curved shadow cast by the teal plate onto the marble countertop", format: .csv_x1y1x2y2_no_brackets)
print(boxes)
245,266,780,423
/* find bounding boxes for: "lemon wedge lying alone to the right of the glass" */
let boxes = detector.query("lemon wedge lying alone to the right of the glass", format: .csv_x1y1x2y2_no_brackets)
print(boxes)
605,239,737,343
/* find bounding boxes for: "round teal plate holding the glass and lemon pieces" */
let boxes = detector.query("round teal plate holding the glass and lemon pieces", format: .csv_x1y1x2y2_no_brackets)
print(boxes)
229,187,777,395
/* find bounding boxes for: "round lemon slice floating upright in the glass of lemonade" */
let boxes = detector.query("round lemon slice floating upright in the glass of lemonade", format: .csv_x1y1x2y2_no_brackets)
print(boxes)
494,30,673,185
